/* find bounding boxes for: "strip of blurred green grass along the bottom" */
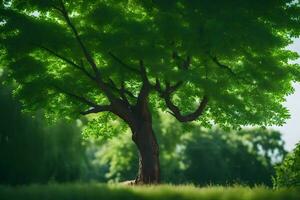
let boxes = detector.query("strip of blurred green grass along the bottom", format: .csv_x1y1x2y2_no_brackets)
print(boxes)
0,184,300,200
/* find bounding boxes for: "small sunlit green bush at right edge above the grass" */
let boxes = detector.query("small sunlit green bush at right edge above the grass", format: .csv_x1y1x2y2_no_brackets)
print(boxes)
274,143,300,188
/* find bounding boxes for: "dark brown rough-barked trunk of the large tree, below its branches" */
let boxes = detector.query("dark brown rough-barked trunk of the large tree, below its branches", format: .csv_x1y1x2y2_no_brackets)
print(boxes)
131,109,160,184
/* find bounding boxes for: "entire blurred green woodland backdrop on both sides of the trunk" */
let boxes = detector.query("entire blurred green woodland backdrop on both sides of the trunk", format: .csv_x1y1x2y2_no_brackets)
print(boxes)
0,80,287,186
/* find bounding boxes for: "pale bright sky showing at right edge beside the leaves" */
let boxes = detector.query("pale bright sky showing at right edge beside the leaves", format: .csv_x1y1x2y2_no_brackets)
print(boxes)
271,39,300,151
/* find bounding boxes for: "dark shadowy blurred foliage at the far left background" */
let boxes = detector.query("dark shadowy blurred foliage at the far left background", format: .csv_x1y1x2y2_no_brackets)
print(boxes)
0,86,84,185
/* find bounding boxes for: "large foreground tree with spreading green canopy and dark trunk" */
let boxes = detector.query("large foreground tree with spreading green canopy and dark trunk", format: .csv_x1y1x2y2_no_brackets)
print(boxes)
1,0,300,183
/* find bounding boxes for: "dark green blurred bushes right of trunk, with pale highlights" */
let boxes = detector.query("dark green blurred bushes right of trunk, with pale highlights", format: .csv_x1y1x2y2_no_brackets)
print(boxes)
184,129,285,186
